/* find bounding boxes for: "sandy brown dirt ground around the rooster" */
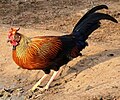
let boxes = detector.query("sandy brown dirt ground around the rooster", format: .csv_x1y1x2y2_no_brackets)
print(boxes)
0,0,120,100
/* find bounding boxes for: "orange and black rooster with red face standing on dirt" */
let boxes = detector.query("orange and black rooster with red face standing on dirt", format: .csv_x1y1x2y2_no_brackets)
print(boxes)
8,5,118,91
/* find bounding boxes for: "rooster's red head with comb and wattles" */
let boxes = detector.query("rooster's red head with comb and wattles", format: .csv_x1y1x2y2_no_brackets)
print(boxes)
7,28,21,46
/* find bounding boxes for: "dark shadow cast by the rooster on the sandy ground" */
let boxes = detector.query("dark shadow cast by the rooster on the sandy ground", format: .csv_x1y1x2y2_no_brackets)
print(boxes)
61,49,120,78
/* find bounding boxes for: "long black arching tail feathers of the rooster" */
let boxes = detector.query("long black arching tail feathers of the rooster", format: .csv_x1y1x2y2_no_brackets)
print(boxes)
72,5,118,42
